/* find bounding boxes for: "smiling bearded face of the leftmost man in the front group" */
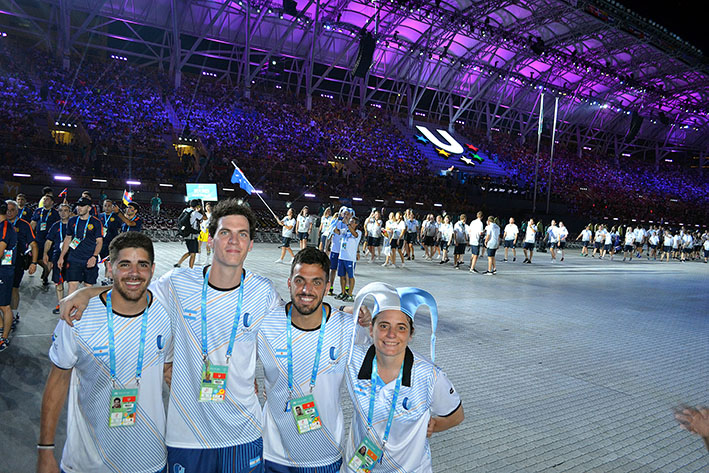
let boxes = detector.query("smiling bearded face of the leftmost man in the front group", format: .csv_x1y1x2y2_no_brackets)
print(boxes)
108,248,155,302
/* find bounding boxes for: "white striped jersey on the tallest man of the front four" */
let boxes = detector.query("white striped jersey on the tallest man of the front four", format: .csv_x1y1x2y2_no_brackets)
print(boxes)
155,268,281,448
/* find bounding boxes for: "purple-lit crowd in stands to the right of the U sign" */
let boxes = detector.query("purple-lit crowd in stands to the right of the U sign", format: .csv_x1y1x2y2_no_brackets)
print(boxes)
466,126,709,222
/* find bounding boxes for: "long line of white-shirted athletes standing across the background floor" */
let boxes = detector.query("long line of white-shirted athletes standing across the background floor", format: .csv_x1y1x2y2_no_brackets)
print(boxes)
277,203,709,280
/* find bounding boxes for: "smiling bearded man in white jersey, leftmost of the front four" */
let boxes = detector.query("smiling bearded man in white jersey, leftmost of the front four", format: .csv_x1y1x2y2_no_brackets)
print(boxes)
37,232,172,473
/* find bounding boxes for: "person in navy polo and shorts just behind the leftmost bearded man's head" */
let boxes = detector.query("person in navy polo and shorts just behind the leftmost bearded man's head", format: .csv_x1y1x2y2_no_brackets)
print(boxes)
57,197,103,294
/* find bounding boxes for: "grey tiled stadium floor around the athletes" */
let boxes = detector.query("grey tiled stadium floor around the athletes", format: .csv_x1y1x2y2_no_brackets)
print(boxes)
0,243,709,473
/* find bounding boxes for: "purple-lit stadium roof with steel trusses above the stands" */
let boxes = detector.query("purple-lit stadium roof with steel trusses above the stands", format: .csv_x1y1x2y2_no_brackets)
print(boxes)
0,0,709,151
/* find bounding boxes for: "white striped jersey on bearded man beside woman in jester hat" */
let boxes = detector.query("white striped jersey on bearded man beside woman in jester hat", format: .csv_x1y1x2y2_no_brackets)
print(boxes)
258,304,355,467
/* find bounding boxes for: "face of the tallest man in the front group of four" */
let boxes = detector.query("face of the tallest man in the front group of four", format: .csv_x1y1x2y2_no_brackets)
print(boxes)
212,215,254,268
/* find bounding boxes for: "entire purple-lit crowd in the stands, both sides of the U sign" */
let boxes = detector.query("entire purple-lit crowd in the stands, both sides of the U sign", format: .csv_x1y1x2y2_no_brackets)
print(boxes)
0,37,709,226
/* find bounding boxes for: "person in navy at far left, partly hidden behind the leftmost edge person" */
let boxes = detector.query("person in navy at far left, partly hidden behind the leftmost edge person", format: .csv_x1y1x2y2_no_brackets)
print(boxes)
6,200,39,329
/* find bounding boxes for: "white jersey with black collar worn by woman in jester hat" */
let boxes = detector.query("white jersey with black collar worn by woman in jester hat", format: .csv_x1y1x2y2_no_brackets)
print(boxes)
344,345,460,473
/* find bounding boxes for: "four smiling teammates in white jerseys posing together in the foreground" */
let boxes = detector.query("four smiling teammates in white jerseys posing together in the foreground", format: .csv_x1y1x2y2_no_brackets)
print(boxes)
37,200,464,473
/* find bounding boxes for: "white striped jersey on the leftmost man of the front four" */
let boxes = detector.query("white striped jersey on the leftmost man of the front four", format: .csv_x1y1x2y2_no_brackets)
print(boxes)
49,288,172,473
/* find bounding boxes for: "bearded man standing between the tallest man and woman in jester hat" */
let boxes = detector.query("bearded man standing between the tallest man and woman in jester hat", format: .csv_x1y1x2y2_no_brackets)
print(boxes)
258,247,368,473
